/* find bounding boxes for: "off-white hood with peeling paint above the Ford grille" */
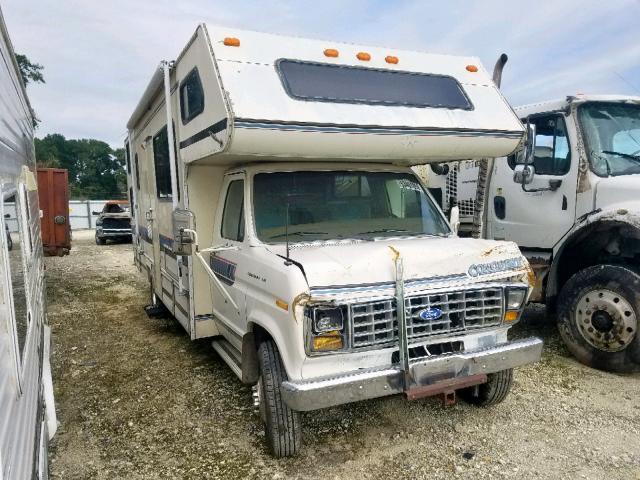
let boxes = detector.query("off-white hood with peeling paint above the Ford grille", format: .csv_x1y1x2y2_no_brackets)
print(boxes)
274,237,526,288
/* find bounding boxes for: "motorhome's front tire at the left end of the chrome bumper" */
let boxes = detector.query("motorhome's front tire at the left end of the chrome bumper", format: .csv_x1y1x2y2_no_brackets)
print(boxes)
258,340,302,457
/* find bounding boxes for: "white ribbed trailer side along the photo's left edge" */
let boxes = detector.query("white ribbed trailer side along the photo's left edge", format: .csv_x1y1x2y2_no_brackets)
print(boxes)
0,5,56,480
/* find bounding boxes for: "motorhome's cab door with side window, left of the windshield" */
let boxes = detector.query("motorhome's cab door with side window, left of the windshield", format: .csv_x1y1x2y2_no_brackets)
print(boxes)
208,173,249,350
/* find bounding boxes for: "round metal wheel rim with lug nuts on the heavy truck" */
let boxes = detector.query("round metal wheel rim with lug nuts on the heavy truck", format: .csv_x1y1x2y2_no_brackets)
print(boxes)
575,289,638,352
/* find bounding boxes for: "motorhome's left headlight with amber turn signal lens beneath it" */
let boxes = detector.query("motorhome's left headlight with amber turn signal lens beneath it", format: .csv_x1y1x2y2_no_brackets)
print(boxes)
306,306,347,352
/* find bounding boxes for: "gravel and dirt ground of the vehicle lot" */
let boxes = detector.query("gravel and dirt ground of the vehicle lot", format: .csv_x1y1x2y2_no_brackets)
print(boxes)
47,233,640,479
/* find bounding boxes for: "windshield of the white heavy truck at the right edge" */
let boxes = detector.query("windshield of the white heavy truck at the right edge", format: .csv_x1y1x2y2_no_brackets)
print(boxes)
579,103,640,177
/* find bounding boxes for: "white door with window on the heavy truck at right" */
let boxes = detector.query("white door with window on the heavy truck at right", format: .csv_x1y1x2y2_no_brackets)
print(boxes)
488,113,578,250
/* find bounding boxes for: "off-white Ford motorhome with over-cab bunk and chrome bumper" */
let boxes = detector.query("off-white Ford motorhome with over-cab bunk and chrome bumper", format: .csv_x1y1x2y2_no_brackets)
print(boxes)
126,25,542,456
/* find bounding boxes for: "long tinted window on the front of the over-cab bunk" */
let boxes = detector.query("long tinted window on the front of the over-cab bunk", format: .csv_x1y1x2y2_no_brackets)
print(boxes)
277,59,473,110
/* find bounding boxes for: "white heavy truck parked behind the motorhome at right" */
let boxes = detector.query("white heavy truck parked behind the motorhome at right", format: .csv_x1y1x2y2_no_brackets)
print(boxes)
421,95,640,371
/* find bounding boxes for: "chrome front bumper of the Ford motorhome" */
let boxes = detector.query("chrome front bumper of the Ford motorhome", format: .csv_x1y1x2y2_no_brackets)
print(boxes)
281,338,542,411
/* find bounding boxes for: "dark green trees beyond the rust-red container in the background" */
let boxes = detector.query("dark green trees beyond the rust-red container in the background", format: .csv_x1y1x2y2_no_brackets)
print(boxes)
35,133,127,200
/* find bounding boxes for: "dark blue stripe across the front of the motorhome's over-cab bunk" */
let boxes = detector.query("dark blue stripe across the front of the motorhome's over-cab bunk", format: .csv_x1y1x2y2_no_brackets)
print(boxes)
233,118,523,139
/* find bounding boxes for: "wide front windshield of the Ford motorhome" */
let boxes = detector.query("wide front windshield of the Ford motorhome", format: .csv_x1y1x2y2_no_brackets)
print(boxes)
253,171,450,243
